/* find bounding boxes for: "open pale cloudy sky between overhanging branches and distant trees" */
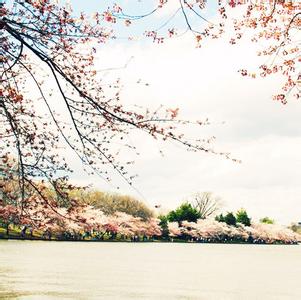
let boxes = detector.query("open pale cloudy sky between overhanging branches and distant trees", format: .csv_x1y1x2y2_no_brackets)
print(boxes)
55,0,301,224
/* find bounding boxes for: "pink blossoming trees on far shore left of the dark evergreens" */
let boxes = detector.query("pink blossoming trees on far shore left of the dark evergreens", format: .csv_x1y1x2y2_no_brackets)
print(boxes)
0,199,161,237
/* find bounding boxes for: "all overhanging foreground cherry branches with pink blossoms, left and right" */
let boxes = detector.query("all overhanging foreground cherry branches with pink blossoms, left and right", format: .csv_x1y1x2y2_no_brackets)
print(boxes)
0,0,301,225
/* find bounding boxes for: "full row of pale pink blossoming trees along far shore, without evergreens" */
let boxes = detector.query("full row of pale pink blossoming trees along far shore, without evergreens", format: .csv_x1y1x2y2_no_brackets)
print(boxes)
0,198,301,244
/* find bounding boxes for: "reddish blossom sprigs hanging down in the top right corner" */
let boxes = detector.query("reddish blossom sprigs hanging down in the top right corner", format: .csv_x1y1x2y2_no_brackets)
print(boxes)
132,0,301,104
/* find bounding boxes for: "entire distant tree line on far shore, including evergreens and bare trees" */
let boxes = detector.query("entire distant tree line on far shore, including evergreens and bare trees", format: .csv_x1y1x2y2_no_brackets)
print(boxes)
0,182,301,244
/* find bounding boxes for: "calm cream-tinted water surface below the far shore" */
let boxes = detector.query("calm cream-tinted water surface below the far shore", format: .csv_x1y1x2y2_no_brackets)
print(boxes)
0,241,301,300
